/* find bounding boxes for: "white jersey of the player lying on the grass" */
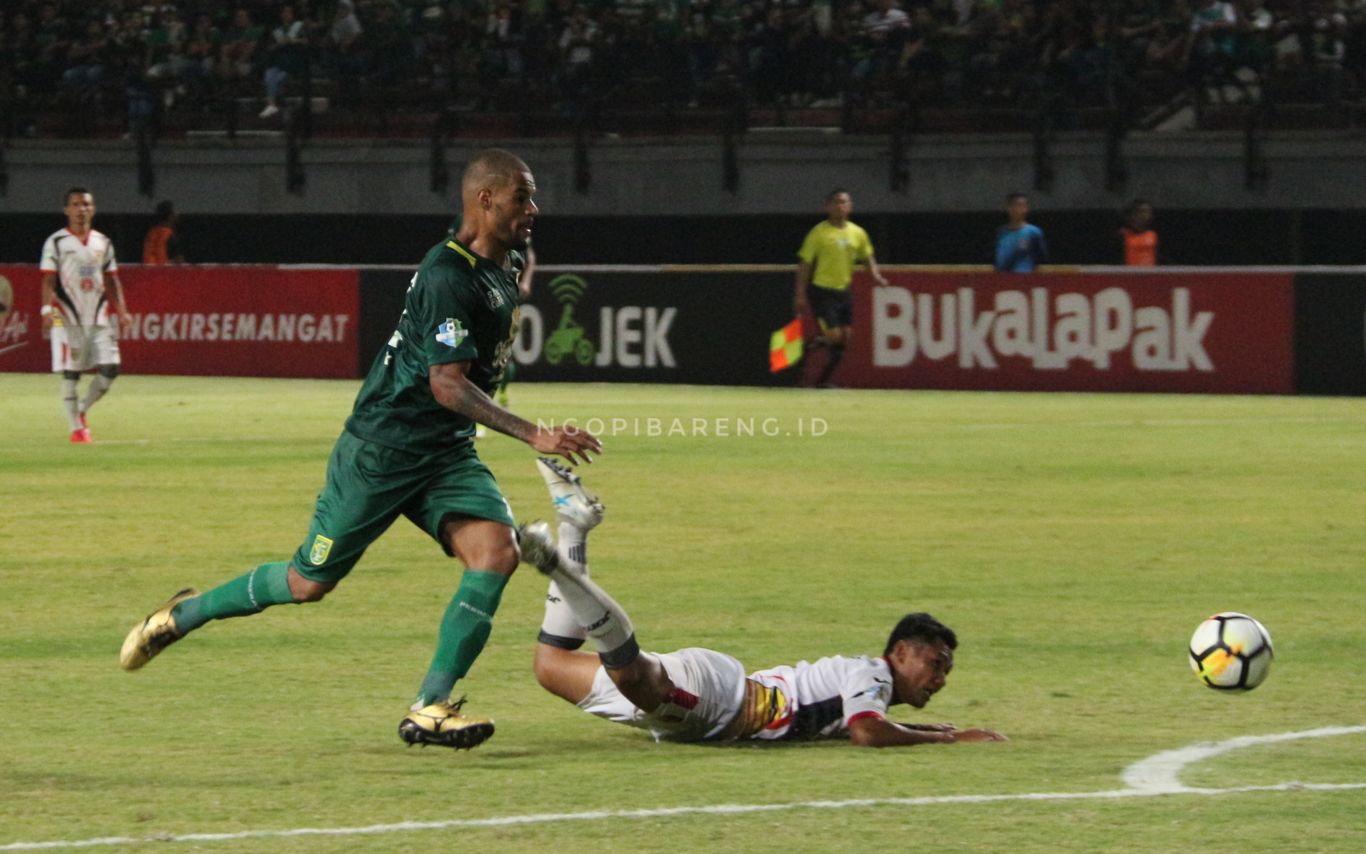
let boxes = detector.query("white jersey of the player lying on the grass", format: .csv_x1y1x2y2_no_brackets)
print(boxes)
750,656,892,739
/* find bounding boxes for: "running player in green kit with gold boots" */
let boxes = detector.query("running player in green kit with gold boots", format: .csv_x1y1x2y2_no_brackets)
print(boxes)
119,149,602,747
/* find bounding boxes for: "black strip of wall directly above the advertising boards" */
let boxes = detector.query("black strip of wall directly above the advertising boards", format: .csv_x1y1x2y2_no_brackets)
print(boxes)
0,204,1349,265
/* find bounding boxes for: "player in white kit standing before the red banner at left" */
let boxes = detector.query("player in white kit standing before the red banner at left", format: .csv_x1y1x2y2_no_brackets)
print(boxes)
38,187,131,444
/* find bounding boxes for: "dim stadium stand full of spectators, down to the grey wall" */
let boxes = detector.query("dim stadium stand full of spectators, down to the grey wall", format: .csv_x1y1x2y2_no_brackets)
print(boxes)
0,0,1366,138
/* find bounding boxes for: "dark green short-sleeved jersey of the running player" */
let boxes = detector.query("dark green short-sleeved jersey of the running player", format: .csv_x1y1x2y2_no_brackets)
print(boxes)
346,240,525,454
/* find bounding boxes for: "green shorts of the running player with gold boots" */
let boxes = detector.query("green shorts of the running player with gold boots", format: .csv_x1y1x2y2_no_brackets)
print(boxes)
292,432,515,583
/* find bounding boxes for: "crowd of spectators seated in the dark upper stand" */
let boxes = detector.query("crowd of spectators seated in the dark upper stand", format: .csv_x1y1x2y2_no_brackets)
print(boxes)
0,0,1366,131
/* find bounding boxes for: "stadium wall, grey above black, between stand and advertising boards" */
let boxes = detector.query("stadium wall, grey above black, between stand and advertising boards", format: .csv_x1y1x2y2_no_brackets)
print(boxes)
8,128,1366,265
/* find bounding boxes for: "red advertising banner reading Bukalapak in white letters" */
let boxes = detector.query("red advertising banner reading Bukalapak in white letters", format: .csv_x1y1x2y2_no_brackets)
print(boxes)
835,272,1294,394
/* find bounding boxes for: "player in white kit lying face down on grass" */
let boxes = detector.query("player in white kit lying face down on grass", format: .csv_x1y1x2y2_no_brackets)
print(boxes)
519,459,1005,747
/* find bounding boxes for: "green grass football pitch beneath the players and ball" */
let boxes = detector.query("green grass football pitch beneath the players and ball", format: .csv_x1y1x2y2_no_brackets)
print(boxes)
0,374,1366,853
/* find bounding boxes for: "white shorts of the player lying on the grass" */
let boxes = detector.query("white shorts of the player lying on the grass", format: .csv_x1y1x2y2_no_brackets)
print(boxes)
578,648,744,742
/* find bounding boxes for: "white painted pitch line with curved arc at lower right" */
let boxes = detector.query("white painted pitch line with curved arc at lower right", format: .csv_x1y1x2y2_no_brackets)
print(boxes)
0,726,1366,851
